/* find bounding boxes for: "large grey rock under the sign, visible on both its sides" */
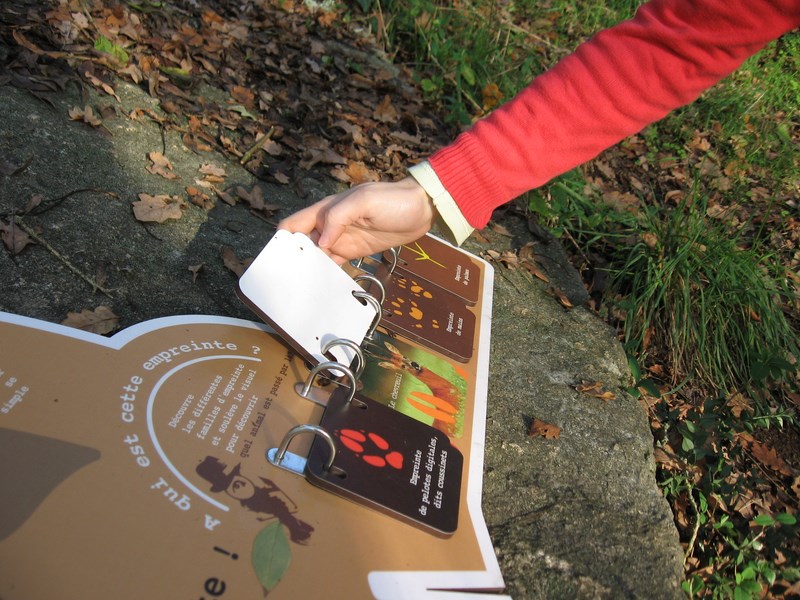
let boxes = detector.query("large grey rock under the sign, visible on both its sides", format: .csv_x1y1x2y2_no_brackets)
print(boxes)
0,77,681,598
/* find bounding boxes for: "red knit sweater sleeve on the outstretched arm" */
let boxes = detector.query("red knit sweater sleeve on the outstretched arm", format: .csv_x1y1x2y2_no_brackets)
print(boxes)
430,0,800,227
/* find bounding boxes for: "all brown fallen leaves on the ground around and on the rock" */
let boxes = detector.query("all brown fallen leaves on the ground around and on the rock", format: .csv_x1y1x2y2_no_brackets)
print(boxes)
0,0,800,597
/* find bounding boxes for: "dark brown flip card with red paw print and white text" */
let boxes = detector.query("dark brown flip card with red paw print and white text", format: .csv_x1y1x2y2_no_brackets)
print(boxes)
305,389,464,536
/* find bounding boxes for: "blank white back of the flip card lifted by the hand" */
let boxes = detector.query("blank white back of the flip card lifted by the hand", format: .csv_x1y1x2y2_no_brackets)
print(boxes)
237,230,378,365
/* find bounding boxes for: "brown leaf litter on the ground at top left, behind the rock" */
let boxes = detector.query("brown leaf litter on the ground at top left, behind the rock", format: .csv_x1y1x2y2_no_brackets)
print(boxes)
0,0,446,200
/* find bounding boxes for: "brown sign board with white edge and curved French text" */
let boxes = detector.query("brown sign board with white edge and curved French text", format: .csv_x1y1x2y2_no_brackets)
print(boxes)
0,240,502,600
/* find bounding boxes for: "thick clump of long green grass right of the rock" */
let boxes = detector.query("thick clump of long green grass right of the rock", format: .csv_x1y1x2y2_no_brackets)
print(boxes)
611,199,798,392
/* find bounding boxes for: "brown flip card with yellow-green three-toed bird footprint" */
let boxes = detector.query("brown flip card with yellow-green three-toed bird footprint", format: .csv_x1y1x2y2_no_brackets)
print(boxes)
384,235,481,306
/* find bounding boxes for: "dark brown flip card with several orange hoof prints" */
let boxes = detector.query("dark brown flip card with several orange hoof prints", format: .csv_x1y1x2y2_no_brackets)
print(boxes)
376,267,476,362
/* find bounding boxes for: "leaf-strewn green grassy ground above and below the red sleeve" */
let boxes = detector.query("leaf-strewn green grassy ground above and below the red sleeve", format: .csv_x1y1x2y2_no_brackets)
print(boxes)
359,0,800,599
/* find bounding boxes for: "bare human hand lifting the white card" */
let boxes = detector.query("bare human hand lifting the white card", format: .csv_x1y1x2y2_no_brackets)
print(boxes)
278,177,435,264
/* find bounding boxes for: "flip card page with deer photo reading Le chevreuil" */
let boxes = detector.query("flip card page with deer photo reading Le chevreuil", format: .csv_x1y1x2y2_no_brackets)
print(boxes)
359,332,468,438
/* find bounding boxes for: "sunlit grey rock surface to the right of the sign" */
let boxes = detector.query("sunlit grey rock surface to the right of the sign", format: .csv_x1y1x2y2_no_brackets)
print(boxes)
466,229,683,598
